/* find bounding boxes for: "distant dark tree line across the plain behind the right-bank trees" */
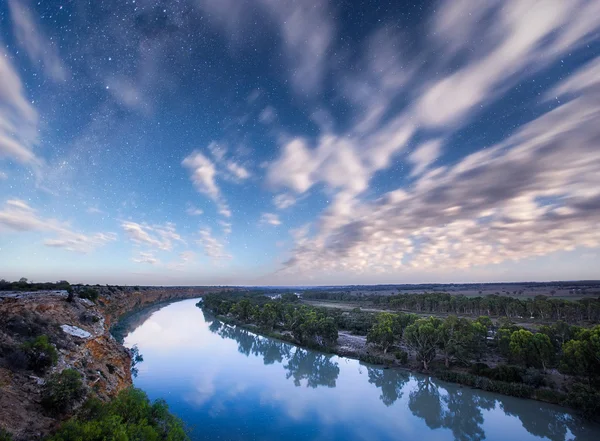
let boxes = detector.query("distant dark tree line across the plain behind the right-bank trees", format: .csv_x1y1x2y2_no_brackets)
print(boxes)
303,291,600,323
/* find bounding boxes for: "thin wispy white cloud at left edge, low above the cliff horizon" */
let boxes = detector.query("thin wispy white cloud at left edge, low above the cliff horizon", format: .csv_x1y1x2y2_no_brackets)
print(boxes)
0,199,117,253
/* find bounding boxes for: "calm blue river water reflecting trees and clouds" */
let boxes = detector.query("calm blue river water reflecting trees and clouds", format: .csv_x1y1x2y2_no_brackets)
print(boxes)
125,300,600,441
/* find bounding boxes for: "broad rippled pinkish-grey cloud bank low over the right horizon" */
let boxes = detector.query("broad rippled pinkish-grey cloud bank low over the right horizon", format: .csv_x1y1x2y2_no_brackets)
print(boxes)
285,96,600,274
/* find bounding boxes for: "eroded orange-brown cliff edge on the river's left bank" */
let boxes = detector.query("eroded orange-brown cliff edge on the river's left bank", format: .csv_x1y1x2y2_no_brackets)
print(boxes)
0,287,220,440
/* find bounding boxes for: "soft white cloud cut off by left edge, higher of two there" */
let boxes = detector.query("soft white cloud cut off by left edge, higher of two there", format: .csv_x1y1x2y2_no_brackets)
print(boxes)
0,50,39,165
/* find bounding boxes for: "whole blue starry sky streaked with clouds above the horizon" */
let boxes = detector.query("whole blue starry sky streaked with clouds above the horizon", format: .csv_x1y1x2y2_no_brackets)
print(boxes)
0,0,600,285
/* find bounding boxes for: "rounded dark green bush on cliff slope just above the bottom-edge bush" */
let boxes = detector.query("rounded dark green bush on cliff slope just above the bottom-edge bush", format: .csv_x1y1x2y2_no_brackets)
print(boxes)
42,369,85,413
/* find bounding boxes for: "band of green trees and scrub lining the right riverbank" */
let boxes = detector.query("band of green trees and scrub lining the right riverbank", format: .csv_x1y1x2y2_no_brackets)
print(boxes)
198,294,600,417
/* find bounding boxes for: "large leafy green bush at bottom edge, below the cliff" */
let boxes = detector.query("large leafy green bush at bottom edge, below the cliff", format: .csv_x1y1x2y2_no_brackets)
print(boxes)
48,388,189,441
